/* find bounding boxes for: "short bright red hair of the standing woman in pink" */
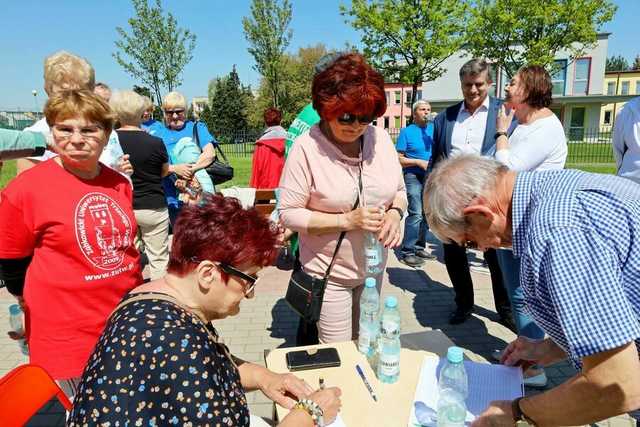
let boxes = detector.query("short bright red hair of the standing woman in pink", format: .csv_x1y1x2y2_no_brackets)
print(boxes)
311,53,387,120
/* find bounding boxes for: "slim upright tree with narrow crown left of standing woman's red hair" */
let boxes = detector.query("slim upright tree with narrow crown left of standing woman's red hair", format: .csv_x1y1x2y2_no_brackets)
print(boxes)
242,0,293,107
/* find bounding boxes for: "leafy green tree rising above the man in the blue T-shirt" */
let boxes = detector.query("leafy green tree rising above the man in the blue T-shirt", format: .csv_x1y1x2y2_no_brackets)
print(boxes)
340,0,468,109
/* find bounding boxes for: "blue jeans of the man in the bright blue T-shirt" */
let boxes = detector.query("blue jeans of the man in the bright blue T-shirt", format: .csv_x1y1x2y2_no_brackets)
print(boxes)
400,172,429,256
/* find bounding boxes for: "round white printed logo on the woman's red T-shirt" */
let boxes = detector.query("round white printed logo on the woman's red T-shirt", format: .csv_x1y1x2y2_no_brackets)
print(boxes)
74,193,133,270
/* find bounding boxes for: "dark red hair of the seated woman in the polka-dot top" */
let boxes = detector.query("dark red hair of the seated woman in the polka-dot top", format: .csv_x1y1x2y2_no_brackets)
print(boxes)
167,195,279,281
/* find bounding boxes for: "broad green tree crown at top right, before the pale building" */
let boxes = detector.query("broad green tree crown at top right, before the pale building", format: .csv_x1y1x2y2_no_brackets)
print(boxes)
466,0,616,77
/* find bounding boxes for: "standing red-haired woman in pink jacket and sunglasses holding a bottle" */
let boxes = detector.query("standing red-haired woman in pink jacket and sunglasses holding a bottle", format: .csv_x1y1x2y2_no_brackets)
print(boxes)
279,53,407,343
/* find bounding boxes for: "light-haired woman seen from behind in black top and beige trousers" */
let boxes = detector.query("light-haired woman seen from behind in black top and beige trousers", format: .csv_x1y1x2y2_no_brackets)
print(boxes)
110,90,174,280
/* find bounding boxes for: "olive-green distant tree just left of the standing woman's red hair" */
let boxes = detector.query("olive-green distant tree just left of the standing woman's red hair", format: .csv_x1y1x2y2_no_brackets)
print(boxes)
249,43,328,128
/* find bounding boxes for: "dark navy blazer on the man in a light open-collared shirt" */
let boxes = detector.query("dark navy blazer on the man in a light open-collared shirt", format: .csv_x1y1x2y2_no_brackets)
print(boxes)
429,96,502,170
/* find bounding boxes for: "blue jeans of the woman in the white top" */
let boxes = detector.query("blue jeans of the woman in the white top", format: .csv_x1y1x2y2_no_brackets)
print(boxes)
496,249,544,340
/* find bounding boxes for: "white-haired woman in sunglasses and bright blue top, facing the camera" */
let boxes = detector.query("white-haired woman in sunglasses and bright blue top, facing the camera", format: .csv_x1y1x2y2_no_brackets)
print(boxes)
154,92,217,224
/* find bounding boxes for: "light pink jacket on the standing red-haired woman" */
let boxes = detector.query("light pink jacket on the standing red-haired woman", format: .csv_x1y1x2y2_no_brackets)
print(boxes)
279,125,407,285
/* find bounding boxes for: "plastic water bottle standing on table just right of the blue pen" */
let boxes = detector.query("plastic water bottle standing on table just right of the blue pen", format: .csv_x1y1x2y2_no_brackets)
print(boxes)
377,296,400,383
